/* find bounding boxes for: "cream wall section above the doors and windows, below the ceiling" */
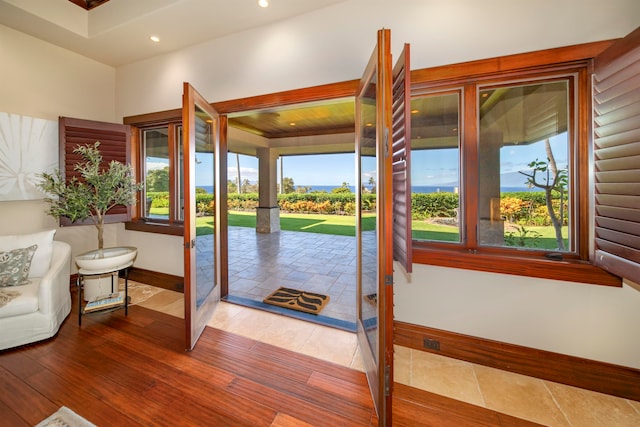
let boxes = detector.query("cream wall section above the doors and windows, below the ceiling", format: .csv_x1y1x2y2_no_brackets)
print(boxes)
116,0,640,116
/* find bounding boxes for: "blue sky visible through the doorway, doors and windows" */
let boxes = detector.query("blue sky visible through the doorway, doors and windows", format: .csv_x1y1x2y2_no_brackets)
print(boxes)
148,134,567,187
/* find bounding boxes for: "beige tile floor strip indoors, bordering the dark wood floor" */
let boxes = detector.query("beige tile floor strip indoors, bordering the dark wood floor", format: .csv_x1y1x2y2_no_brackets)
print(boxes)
130,290,640,427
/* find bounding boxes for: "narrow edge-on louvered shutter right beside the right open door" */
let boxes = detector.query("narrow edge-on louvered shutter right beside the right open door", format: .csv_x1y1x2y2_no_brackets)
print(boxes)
392,44,413,273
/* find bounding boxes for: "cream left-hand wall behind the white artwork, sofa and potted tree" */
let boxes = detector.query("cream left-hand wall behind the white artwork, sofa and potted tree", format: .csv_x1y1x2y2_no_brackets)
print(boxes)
0,25,116,268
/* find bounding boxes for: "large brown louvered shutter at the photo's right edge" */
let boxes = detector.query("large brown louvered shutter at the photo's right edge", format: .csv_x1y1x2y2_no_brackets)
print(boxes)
593,28,640,281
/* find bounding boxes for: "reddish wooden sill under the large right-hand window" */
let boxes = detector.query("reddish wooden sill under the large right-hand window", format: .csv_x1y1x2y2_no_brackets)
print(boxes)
413,245,622,287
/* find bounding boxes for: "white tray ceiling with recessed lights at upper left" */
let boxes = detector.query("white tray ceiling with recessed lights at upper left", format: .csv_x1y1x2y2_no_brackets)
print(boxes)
0,0,345,67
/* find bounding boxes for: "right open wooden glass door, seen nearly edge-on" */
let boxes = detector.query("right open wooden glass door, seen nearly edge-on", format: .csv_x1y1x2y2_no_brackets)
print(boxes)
356,30,393,426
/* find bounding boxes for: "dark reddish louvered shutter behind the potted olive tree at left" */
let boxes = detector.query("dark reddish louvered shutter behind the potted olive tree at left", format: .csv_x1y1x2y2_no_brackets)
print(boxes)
58,117,131,226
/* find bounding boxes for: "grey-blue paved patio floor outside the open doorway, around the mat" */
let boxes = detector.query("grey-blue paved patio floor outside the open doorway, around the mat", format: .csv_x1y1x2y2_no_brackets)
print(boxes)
229,227,356,331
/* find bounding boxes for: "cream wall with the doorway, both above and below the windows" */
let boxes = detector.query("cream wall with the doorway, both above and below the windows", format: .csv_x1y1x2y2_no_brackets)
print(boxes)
116,0,640,368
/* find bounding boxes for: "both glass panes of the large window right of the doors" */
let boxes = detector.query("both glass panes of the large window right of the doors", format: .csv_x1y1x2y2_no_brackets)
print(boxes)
411,77,575,252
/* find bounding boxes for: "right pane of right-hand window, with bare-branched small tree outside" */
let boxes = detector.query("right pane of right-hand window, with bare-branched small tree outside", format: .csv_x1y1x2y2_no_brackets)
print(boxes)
477,77,576,252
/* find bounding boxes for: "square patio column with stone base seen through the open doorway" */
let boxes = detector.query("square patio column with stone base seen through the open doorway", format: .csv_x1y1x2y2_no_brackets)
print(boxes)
256,148,280,233
